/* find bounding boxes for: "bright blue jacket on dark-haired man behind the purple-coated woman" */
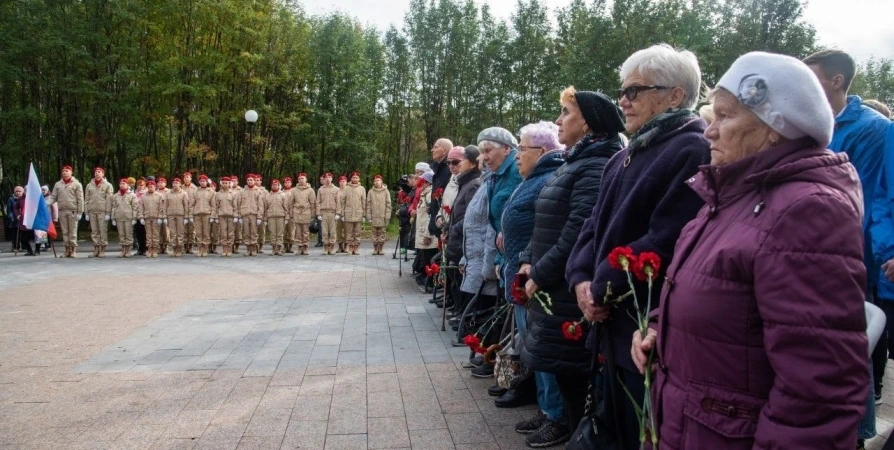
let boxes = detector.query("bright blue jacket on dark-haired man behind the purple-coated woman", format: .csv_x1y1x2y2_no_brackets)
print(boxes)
829,95,891,285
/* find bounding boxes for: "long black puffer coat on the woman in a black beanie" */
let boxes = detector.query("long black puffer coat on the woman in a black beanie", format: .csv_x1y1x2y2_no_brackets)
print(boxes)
521,135,621,373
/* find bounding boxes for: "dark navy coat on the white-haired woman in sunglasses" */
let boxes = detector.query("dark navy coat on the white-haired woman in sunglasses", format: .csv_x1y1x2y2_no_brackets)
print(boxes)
565,118,710,371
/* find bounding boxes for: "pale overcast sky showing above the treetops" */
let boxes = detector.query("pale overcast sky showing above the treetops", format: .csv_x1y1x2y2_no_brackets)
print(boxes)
304,0,894,61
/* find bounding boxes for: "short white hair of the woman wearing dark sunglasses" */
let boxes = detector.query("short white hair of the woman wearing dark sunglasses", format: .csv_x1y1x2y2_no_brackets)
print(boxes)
621,44,702,109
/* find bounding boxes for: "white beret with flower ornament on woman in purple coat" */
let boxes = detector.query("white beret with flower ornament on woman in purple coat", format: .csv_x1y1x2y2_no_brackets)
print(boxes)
717,52,835,147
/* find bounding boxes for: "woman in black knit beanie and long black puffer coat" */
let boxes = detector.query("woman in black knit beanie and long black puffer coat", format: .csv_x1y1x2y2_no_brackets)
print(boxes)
516,87,624,442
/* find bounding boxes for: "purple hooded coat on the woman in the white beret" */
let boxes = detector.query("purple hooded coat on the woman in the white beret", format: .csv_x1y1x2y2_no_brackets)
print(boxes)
652,139,870,450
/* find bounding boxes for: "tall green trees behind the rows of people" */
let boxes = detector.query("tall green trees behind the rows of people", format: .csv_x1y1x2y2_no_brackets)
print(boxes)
0,0,894,197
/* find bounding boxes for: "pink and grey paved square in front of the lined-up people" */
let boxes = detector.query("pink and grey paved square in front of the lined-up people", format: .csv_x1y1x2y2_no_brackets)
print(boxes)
0,244,894,450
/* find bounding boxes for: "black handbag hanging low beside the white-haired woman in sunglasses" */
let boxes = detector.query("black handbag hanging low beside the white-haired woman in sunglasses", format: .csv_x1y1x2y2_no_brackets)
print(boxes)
565,326,621,450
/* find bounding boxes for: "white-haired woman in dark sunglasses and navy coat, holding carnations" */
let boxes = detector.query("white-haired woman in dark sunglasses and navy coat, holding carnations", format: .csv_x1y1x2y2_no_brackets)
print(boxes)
565,45,710,449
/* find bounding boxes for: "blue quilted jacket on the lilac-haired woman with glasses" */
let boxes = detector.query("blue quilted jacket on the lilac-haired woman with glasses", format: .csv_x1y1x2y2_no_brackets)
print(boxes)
500,150,565,301
